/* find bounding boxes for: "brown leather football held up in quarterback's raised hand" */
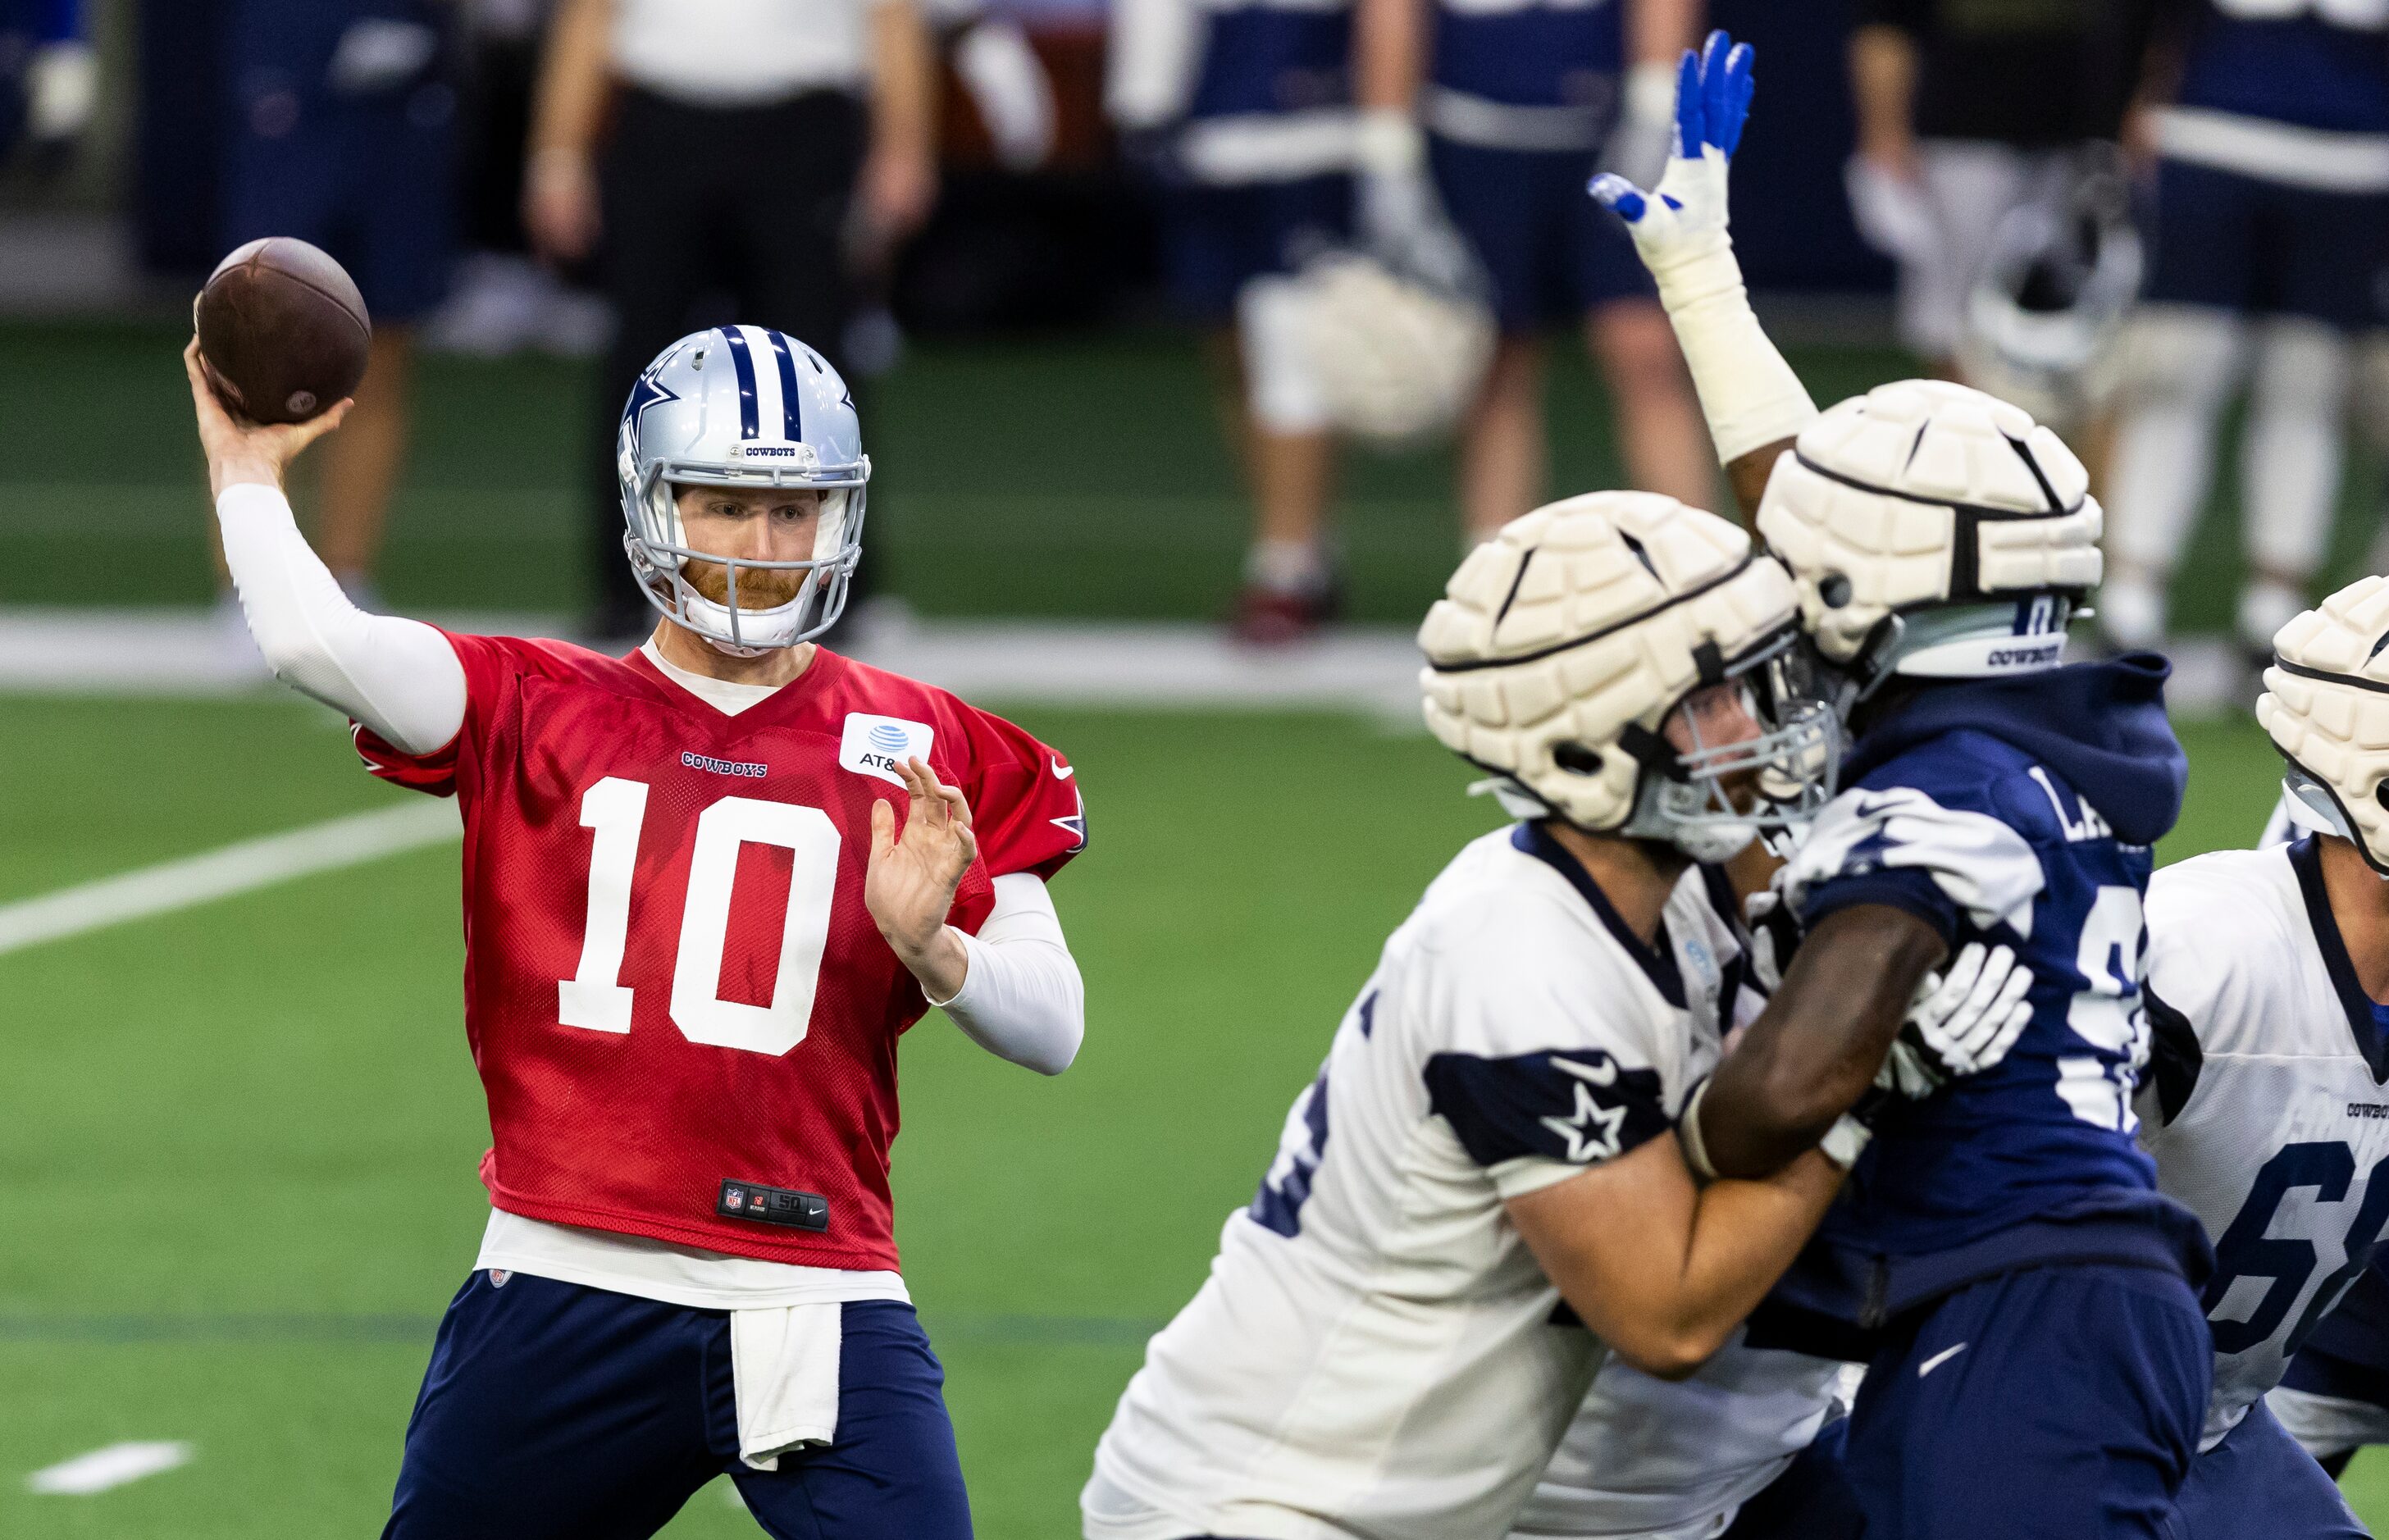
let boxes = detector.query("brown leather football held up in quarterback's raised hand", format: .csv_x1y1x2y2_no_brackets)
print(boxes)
194,236,372,422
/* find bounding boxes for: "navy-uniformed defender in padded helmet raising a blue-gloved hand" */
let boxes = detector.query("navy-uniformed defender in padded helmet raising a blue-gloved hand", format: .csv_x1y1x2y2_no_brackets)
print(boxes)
1593,36,2212,1540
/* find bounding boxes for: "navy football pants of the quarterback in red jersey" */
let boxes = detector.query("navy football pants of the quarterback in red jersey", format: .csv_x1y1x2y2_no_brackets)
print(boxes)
382,1273,970,1540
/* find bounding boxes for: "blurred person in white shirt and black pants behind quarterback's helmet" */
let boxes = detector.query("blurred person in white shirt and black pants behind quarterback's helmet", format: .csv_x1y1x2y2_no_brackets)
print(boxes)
523,0,937,637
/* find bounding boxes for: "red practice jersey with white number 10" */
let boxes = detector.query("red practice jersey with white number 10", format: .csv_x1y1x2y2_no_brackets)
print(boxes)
356,635,1087,1270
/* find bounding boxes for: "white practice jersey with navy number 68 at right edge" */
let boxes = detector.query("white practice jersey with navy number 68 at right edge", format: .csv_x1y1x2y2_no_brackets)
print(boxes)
2138,838,2389,1449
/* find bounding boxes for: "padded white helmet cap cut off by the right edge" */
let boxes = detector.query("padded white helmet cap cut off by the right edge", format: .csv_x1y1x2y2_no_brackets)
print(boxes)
2255,578,2389,877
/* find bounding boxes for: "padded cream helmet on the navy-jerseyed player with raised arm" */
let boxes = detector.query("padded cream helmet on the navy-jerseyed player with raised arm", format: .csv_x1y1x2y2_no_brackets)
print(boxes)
1758,380,2102,699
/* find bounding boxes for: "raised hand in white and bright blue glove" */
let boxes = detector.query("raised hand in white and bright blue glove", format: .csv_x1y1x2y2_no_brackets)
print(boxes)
1586,31,1756,294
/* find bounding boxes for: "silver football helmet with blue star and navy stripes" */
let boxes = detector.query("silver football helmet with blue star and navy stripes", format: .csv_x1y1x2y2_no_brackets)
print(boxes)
614,327,872,657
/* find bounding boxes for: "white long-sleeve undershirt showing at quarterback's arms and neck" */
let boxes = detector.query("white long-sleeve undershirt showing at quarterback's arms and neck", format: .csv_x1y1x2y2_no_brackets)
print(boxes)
215,485,1087,1074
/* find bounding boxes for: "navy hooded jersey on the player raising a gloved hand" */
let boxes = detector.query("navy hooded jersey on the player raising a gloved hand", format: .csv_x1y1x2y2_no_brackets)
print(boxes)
1780,657,2205,1325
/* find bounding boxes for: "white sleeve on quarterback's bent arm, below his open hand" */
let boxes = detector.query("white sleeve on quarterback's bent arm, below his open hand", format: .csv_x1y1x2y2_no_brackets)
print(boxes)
929,872,1087,1074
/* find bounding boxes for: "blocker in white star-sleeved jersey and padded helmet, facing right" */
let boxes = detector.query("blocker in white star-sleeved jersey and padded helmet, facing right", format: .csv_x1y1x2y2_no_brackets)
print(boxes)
1083,475,1940,1540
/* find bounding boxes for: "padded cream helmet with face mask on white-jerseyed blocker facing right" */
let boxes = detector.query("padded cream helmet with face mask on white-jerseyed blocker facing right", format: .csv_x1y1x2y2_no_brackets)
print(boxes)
1419,492,1840,862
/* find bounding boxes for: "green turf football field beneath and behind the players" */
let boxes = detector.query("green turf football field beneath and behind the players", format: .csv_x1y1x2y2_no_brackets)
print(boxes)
14,312,2389,1540
